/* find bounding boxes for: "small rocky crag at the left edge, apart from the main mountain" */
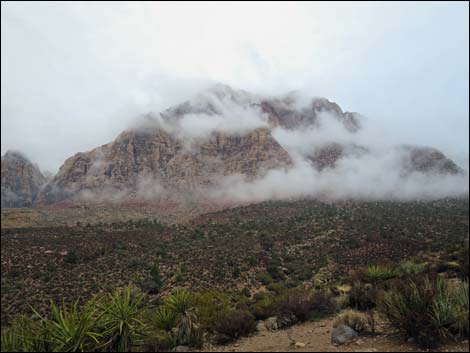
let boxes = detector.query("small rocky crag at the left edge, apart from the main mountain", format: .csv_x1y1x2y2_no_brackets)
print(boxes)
1,152,46,207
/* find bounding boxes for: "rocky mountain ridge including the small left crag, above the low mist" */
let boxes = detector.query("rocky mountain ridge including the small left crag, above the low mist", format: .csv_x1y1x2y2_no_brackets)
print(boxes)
2,85,463,207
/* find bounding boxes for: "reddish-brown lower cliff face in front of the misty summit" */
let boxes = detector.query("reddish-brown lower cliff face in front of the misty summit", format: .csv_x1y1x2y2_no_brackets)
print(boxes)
41,128,292,202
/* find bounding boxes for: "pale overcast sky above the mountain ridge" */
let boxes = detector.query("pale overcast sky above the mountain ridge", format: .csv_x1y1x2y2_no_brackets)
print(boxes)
1,1,469,172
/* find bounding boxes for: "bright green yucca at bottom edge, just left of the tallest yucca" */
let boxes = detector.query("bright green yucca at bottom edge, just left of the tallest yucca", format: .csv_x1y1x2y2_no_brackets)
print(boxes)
33,299,103,352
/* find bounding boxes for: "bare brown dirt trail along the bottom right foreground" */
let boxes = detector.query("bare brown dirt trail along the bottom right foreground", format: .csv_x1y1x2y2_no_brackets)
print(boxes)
208,318,469,352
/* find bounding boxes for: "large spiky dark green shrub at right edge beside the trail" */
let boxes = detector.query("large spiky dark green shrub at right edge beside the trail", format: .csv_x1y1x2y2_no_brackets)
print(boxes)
379,276,468,348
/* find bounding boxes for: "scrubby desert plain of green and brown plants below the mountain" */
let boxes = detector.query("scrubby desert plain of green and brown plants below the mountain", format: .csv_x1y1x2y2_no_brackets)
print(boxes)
1,199,468,351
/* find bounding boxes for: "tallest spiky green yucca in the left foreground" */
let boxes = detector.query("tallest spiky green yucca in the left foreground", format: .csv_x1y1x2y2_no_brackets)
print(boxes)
99,286,146,352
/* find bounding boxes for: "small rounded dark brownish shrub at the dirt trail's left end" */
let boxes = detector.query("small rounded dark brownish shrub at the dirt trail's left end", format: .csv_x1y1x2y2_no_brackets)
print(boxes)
214,309,256,343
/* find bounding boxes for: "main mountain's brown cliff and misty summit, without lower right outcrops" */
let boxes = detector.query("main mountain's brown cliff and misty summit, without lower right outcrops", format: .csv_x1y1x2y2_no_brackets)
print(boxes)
40,85,359,203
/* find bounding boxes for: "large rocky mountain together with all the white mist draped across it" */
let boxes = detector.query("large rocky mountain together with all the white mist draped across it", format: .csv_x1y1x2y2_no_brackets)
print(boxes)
2,84,468,206
